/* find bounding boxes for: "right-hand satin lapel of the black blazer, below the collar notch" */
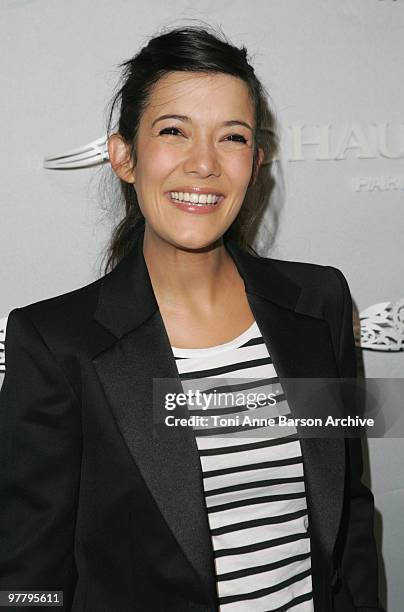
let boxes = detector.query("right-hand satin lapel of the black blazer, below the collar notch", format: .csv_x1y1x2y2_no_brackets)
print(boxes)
245,295,345,560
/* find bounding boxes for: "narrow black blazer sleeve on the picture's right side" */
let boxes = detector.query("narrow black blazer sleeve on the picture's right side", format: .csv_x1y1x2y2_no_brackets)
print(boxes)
331,268,384,612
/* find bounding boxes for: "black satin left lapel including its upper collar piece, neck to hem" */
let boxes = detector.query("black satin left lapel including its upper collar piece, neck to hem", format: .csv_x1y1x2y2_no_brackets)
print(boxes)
93,228,217,607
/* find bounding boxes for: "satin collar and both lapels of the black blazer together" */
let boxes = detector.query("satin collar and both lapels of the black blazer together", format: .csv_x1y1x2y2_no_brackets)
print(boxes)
93,226,345,605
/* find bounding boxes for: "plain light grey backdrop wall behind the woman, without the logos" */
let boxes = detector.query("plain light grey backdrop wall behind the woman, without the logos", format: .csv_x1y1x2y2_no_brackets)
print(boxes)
0,0,404,612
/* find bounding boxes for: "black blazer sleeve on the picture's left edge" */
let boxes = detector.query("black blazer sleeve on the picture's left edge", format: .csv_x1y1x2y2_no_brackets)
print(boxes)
0,309,81,610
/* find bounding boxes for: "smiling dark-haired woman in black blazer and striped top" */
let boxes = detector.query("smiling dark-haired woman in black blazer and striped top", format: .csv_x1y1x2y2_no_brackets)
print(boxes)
0,27,381,612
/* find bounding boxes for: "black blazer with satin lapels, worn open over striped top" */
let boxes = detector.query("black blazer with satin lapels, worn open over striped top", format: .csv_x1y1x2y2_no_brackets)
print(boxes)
0,227,381,612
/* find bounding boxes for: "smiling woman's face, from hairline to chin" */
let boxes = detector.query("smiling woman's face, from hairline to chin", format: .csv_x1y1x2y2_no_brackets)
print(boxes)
110,72,262,249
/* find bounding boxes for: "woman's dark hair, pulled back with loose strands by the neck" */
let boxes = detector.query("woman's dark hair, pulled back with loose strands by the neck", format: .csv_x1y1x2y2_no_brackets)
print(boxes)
105,25,278,272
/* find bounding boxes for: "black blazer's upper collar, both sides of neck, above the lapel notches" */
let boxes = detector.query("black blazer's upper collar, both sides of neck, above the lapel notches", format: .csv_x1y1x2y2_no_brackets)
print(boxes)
95,225,301,338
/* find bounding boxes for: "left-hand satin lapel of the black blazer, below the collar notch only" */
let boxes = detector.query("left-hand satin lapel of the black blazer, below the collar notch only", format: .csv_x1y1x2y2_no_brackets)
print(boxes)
93,311,219,601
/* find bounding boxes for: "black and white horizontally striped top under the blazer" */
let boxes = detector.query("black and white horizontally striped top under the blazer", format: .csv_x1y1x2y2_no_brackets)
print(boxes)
172,322,313,612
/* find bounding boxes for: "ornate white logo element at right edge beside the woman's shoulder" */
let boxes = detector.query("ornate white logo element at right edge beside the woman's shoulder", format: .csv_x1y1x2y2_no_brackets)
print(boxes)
359,298,404,351
